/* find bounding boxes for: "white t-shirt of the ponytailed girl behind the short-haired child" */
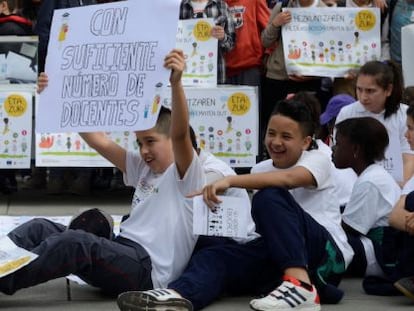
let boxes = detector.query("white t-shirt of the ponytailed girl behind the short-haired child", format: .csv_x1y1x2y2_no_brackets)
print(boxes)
335,101,414,182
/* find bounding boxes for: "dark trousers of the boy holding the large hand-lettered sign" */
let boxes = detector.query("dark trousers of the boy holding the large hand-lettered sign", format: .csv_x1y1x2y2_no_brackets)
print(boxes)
0,218,152,295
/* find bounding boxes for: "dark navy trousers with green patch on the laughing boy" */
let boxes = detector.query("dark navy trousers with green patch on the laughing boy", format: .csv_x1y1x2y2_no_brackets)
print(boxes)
169,188,345,310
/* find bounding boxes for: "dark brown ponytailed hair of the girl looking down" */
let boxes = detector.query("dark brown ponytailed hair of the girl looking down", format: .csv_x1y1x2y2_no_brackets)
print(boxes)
358,60,403,119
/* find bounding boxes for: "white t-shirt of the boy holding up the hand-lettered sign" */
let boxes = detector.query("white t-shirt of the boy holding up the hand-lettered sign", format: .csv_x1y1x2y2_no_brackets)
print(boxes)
120,152,205,288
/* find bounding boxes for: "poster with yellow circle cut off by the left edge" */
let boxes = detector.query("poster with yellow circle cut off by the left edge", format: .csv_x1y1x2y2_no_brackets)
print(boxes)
0,86,34,169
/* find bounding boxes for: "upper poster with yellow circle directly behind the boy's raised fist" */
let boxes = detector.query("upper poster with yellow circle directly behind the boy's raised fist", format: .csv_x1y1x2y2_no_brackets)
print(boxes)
176,18,218,87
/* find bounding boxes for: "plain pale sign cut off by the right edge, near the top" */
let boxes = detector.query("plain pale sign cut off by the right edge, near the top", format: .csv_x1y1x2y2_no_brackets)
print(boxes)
401,23,414,87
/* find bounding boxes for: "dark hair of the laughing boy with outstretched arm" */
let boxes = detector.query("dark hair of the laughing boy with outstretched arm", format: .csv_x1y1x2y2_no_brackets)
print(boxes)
270,97,320,150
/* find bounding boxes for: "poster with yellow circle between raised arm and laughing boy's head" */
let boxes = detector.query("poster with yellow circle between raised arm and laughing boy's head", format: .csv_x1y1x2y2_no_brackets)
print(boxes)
163,86,259,167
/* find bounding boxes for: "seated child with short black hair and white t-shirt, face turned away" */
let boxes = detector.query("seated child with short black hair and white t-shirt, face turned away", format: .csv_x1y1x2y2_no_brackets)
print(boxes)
333,117,401,293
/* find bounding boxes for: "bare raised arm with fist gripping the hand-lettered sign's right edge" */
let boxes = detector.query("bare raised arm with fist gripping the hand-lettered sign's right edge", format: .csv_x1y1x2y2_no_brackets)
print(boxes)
164,49,194,178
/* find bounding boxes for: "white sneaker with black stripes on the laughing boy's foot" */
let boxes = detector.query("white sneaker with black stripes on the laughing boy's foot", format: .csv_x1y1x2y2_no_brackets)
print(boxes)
250,277,321,311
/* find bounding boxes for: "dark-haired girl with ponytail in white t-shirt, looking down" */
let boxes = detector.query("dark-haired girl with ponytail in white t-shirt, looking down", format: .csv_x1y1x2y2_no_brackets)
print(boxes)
336,61,414,185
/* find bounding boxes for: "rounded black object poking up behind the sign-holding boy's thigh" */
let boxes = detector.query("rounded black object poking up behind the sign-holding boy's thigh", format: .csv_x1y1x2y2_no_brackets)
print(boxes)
68,208,114,240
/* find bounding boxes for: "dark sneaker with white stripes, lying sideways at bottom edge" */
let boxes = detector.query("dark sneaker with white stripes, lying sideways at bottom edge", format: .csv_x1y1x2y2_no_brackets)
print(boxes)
117,289,193,311
